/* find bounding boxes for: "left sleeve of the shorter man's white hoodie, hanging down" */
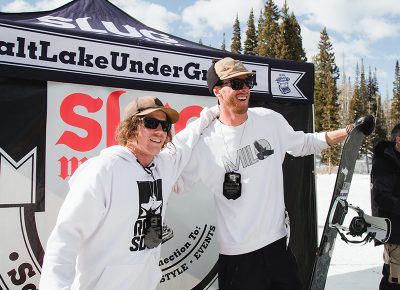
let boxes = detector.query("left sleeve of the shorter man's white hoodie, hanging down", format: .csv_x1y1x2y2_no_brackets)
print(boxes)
39,160,107,290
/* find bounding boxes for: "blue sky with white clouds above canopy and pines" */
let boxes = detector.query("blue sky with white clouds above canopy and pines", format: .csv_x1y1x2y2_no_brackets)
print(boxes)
0,0,400,99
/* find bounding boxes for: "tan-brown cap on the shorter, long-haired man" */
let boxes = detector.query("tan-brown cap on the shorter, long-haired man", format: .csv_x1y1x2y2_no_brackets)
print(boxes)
124,96,179,124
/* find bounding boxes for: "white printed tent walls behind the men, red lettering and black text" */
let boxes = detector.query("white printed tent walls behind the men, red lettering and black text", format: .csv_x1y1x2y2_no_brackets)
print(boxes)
0,82,218,290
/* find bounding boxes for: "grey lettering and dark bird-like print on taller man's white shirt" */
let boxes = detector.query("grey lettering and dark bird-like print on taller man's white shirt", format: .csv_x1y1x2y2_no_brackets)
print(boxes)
222,139,274,172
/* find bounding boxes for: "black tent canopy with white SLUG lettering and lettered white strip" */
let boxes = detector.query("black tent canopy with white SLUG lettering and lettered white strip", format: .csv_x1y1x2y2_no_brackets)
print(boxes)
0,0,313,102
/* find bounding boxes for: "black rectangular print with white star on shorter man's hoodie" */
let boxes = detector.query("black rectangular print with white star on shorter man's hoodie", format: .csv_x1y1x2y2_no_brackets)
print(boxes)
130,179,163,251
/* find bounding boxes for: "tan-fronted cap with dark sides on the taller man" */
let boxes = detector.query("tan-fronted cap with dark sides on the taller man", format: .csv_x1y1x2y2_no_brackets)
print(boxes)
207,57,256,95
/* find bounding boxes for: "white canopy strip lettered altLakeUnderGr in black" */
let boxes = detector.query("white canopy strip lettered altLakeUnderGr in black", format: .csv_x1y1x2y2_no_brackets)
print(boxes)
0,24,270,93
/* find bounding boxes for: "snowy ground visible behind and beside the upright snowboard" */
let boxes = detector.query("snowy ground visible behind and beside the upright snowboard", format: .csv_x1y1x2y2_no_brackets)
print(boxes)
317,174,383,290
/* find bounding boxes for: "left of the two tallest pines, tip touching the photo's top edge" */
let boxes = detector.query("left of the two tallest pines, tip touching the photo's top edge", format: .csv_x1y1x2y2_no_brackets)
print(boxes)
257,0,280,58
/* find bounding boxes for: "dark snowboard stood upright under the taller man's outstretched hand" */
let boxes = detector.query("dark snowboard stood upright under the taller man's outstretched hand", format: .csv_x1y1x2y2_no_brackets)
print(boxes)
309,116,375,290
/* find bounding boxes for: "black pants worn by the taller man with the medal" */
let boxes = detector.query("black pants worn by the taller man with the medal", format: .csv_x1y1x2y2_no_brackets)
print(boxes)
218,238,303,290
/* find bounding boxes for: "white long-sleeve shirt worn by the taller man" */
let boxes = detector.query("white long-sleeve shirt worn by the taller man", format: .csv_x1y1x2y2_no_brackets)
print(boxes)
174,108,328,255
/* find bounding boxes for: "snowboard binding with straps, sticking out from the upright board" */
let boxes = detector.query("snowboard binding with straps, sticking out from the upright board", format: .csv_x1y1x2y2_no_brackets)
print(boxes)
329,196,391,245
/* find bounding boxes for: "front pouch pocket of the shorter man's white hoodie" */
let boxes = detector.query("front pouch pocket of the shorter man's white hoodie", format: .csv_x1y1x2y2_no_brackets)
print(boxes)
94,259,161,290
